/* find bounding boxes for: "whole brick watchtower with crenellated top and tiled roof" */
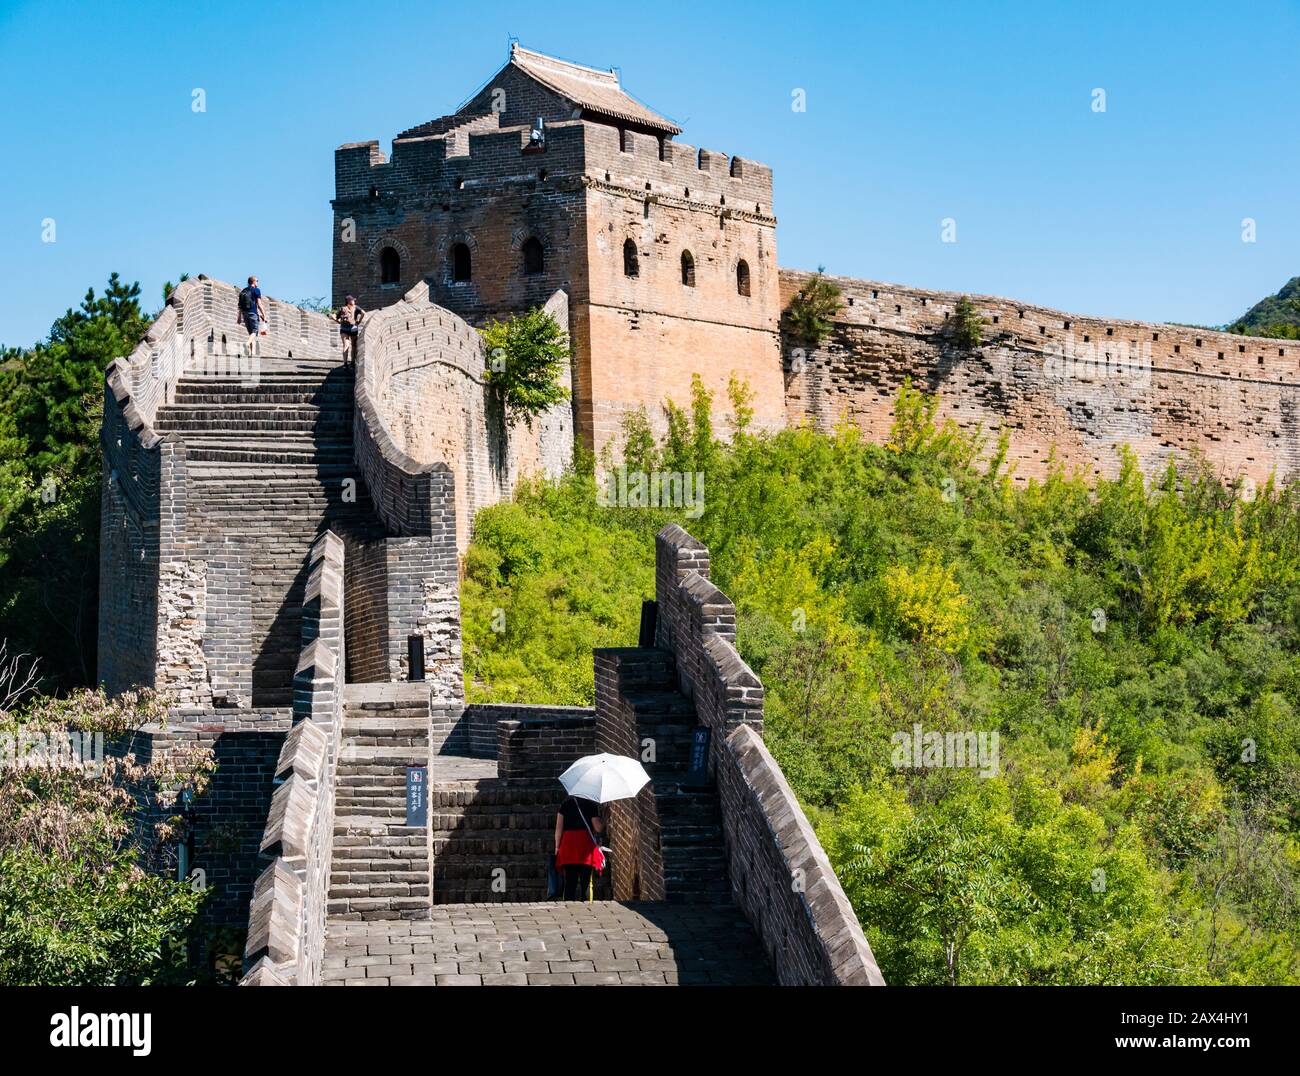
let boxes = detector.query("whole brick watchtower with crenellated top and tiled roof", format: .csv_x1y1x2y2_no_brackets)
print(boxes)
333,44,784,451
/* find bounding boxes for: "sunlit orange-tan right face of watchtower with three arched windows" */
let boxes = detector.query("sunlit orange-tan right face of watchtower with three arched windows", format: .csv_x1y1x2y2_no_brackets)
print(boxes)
575,125,785,451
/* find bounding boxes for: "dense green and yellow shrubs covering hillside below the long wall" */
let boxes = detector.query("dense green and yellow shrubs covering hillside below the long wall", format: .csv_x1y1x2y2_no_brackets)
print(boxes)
463,383,1300,984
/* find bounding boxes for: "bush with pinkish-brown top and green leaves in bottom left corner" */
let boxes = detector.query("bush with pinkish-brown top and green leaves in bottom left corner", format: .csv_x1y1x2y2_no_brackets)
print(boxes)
0,691,215,986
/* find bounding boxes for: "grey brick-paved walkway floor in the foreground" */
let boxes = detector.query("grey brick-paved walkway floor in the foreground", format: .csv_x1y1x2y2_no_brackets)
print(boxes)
322,901,772,986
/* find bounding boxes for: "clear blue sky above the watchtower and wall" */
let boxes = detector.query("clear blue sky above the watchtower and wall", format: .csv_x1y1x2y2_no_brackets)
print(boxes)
0,0,1300,344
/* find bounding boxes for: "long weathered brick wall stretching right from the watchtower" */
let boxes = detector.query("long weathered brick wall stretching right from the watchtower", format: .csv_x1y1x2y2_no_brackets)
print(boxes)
780,269,1300,482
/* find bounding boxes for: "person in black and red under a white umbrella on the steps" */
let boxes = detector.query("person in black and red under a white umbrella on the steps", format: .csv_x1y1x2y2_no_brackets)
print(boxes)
555,754,650,901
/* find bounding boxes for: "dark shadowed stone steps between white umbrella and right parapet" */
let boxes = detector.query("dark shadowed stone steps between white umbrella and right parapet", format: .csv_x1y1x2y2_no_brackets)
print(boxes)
608,648,731,904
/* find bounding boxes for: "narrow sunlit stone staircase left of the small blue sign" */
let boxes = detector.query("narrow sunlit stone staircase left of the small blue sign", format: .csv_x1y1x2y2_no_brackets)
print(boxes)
328,684,429,920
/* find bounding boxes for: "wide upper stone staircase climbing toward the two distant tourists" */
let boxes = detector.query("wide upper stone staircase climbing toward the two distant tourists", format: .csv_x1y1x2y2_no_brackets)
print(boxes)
157,357,384,706
